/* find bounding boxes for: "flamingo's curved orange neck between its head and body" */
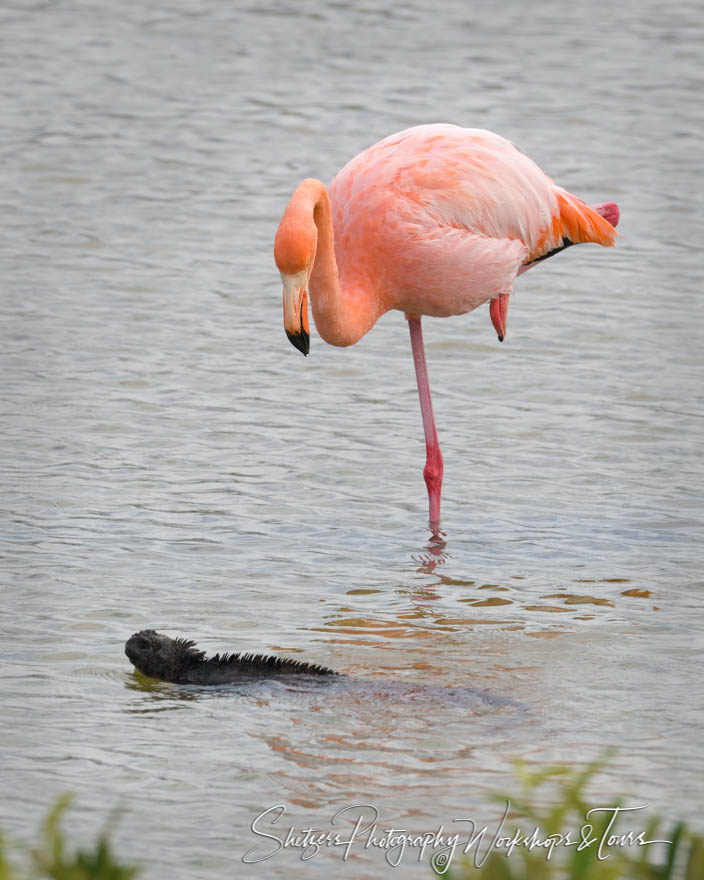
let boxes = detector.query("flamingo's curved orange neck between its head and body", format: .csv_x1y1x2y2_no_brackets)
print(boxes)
287,177,386,346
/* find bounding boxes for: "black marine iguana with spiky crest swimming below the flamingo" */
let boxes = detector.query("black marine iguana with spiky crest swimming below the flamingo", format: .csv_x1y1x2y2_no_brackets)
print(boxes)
125,629,340,685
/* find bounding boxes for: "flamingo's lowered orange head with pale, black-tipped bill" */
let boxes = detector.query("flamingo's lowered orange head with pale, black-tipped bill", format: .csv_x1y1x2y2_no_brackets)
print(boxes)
274,211,317,355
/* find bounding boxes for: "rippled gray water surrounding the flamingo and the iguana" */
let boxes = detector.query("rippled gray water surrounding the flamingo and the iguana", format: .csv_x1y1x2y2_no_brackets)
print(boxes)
0,0,704,880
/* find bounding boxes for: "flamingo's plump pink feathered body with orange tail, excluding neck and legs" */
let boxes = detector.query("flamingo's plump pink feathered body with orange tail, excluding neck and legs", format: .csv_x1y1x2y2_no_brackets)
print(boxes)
330,125,615,316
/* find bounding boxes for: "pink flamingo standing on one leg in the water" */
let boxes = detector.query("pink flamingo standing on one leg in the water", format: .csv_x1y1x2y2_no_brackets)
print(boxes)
274,124,619,536
